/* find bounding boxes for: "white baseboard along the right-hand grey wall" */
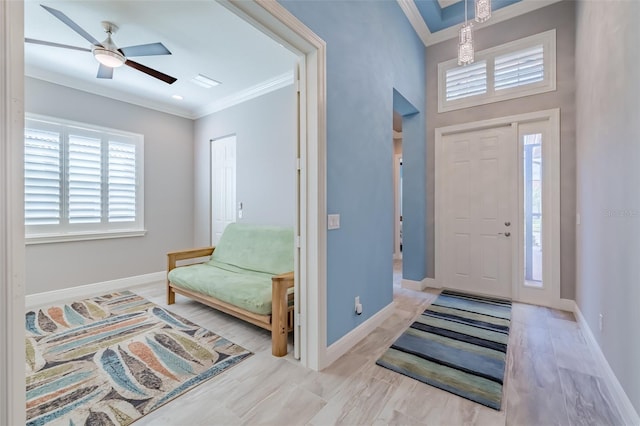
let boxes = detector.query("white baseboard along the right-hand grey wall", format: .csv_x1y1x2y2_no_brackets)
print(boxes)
573,303,640,425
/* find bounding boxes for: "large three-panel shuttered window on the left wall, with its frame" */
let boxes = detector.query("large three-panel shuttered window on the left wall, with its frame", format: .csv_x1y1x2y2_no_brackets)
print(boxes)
24,115,144,243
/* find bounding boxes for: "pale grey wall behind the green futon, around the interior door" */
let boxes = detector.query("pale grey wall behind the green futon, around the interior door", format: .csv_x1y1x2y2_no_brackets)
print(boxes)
194,85,296,246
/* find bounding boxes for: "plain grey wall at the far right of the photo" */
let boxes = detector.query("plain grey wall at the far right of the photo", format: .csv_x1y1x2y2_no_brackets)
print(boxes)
576,1,640,412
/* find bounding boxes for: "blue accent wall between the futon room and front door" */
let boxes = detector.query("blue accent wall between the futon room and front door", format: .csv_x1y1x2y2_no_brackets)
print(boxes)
280,0,426,345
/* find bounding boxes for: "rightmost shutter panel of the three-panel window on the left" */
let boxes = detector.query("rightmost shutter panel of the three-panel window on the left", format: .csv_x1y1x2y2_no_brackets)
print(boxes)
108,141,136,222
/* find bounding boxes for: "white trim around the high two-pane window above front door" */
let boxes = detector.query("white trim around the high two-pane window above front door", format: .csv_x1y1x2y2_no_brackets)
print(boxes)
438,29,556,113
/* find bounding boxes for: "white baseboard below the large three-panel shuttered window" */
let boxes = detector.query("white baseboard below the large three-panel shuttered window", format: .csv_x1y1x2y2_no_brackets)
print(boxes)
25,271,167,308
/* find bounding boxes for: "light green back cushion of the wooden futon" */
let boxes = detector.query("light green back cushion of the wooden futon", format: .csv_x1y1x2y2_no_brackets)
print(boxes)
208,223,294,275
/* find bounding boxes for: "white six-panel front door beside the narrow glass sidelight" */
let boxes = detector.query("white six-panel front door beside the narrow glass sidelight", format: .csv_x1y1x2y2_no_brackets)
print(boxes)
439,126,518,297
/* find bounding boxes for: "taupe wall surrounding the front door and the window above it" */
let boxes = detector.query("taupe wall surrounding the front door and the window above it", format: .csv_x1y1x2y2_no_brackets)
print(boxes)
427,1,576,300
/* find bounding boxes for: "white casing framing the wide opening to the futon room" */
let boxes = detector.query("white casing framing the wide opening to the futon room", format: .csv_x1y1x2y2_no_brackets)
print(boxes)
0,0,327,424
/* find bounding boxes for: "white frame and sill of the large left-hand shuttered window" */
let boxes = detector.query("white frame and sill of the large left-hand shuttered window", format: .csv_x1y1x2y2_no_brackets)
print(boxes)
23,113,147,245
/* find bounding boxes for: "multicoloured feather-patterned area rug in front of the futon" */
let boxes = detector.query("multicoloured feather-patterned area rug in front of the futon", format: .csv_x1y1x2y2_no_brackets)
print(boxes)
25,291,252,426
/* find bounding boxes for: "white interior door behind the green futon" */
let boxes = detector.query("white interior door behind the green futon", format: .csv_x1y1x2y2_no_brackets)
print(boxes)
211,135,236,246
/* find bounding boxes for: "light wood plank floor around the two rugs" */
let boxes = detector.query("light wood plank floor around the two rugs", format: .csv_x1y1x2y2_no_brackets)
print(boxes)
127,266,622,426
